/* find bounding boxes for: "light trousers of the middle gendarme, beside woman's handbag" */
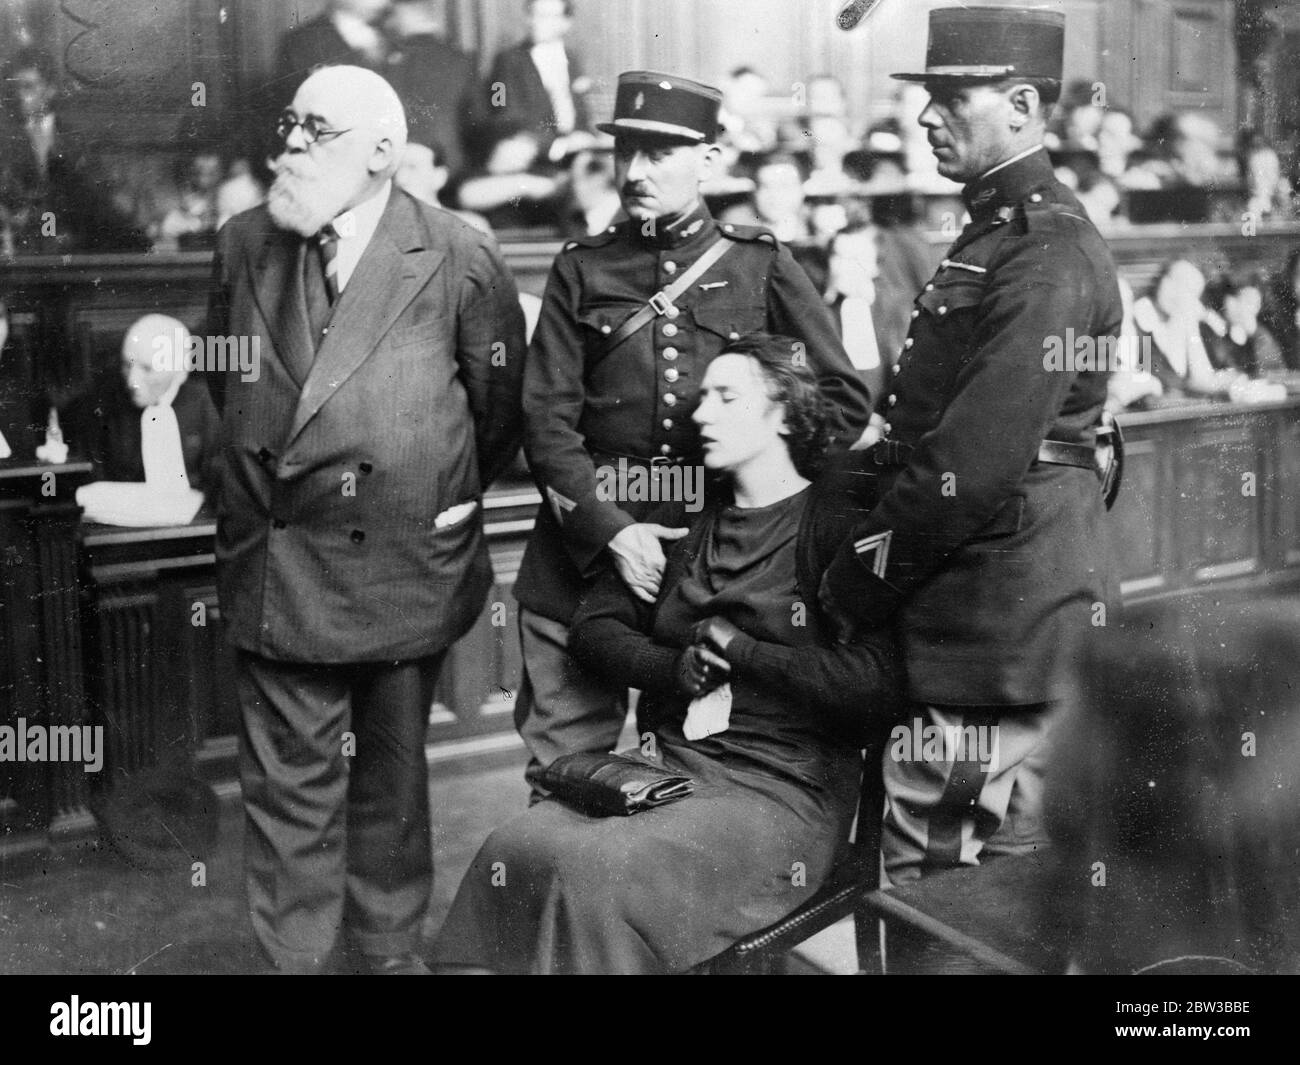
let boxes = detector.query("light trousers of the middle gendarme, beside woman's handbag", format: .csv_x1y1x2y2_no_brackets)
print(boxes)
515,606,628,802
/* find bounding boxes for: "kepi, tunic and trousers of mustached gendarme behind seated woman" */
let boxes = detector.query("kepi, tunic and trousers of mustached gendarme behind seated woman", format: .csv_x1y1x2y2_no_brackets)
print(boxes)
515,72,870,795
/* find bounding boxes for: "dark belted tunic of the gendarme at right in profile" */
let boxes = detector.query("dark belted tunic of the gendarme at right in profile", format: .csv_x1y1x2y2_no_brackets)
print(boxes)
827,148,1122,706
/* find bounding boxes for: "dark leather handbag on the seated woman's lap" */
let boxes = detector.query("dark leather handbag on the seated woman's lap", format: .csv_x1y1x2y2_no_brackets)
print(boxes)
541,752,696,817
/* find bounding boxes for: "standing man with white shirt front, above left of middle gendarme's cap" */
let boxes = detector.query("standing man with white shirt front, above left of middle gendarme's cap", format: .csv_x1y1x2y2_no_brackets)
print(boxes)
476,0,594,163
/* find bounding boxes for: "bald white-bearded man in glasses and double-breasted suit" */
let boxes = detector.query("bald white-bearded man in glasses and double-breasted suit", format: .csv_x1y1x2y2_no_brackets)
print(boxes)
208,66,524,973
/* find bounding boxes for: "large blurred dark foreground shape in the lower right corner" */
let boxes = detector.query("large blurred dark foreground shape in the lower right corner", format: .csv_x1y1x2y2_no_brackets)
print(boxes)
1044,599,1300,974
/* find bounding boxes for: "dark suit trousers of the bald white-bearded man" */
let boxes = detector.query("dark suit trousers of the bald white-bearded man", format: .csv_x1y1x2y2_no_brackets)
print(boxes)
235,651,443,973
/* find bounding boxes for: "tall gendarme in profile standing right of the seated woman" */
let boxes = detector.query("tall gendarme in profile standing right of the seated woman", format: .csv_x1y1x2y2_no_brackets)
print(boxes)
822,8,1122,883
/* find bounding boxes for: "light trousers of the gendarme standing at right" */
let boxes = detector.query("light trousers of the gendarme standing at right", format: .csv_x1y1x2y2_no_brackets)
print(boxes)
881,702,1058,884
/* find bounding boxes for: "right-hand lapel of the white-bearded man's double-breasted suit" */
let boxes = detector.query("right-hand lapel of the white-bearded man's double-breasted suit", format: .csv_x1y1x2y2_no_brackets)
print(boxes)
286,187,446,446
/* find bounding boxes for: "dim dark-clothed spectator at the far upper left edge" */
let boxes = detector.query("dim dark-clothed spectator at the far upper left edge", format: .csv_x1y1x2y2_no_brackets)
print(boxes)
0,47,148,254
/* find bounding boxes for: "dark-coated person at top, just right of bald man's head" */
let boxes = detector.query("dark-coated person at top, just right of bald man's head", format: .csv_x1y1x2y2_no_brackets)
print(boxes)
384,0,478,173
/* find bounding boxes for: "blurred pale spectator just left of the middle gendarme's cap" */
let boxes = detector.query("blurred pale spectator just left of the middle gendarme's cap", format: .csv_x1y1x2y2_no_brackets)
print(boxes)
455,126,563,230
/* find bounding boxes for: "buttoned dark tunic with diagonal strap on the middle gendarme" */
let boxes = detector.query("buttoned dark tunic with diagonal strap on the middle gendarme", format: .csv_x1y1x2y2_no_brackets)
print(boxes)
515,205,870,624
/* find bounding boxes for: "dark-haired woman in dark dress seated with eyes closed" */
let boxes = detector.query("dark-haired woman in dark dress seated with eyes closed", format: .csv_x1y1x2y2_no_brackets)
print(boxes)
436,334,901,973
